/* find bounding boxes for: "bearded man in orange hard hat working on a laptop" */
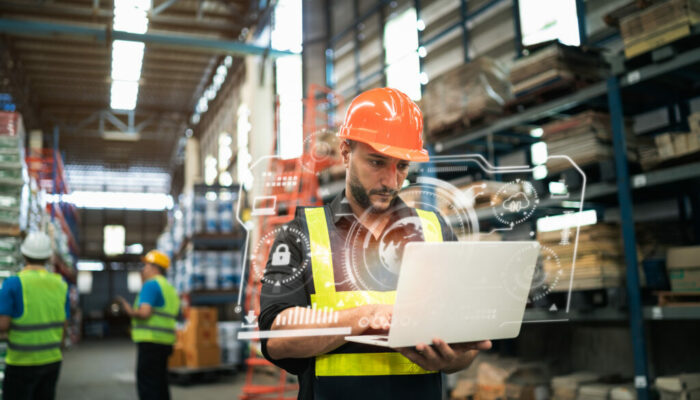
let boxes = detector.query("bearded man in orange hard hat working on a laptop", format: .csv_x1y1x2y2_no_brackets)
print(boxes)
259,88,491,400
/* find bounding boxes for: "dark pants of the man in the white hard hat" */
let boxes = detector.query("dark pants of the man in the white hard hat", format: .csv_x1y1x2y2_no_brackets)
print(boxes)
2,361,61,400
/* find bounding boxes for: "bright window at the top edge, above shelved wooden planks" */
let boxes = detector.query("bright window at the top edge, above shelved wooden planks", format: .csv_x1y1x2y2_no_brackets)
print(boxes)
519,0,581,46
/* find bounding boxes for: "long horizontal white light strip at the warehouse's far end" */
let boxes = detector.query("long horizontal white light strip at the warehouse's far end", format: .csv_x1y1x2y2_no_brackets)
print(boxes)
47,191,173,211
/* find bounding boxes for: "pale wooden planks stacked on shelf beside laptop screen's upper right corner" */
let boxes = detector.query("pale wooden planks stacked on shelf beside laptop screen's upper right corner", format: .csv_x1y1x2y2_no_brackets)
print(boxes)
537,223,625,291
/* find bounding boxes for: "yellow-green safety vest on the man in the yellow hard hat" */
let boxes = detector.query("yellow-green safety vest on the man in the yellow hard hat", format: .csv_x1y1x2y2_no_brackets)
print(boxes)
131,275,180,344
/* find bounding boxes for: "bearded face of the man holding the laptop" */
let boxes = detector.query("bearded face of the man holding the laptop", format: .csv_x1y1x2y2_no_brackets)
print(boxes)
340,142,409,213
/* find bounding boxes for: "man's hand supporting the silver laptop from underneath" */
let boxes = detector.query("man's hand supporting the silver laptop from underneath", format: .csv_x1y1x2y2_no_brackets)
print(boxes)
397,339,491,374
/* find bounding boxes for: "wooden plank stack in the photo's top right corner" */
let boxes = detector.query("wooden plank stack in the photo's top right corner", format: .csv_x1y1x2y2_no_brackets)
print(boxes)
620,0,700,58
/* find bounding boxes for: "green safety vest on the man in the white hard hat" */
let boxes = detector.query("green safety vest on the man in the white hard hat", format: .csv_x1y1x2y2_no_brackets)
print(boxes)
6,270,68,366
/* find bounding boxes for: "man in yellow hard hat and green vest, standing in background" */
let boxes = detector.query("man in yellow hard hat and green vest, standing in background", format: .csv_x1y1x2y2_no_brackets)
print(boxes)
119,250,180,400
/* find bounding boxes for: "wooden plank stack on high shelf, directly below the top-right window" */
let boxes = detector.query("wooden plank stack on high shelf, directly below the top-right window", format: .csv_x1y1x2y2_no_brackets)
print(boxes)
510,42,605,97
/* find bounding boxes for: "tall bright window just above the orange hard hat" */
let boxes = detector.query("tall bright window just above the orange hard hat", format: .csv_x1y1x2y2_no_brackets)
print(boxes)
384,8,428,100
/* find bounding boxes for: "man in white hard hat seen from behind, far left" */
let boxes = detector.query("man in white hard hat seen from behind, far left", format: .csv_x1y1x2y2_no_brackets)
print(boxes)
0,232,70,400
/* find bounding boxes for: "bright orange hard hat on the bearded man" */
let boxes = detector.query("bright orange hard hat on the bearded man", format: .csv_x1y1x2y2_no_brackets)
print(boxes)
338,88,430,161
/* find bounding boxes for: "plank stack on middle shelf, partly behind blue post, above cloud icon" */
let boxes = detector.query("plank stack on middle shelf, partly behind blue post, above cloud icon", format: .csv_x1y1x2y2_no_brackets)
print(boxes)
542,111,637,173
